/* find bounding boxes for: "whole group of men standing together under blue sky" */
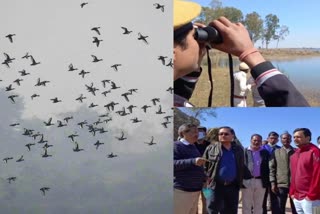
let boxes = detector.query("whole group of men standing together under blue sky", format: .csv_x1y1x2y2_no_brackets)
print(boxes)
174,124,320,214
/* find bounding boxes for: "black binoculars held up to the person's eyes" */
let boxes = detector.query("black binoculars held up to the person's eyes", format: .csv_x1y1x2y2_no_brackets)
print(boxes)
194,26,223,44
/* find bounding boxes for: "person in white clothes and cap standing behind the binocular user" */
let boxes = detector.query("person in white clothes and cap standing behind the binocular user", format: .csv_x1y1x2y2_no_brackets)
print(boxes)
233,62,251,107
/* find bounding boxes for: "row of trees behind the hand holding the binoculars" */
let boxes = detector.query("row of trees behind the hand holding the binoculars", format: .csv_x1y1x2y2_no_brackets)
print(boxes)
196,0,289,49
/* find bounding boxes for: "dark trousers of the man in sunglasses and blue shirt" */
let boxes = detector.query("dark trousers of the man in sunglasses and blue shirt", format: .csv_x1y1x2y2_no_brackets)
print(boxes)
207,183,240,214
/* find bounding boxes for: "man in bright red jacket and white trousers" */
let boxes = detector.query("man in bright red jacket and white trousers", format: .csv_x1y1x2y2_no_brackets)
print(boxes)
289,128,320,214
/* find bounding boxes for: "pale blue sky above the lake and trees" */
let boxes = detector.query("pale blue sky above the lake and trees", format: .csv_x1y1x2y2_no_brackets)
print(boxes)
192,0,320,48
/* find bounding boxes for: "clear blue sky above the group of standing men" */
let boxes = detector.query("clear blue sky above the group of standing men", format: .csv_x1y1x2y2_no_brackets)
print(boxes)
186,108,320,146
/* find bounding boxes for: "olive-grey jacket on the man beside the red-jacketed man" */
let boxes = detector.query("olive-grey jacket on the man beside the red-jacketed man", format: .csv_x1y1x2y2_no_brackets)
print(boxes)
269,147,295,188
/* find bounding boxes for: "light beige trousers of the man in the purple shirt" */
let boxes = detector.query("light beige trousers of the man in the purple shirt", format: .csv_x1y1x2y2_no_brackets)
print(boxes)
241,178,266,214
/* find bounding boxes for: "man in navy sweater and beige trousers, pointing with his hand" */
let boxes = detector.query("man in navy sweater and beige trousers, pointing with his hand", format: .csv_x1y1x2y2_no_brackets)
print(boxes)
173,124,205,214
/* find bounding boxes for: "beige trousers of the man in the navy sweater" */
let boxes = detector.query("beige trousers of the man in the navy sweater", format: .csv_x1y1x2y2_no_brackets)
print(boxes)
173,189,200,214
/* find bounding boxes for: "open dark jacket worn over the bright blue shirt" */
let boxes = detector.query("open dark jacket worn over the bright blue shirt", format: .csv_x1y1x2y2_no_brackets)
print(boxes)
203,142,244,188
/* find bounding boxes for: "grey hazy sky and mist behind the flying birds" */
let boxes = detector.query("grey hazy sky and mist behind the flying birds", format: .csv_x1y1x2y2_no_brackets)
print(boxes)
0,0,172,213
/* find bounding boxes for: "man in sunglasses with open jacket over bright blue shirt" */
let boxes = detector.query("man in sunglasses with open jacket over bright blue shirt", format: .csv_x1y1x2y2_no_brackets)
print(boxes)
203,126,244,214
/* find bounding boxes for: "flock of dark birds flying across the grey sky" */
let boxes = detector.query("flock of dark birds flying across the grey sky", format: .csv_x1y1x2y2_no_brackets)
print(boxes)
0,2,173,195
